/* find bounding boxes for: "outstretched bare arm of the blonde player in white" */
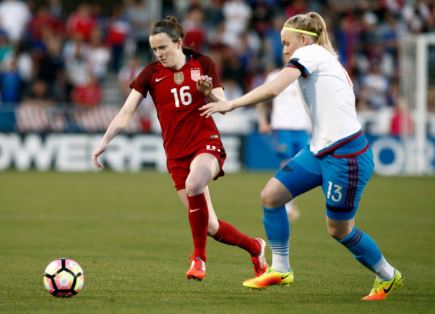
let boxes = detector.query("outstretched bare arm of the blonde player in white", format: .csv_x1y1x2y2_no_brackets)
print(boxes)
200,67,301,117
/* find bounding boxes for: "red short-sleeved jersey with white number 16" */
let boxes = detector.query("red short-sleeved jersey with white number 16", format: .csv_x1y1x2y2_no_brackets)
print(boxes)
130,49,221,159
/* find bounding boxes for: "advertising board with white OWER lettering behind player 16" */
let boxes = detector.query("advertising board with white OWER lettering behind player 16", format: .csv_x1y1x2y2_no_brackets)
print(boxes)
0,133,241,172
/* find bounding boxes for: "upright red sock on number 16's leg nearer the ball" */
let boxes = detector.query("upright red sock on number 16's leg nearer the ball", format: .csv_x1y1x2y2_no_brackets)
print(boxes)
187,193,208,262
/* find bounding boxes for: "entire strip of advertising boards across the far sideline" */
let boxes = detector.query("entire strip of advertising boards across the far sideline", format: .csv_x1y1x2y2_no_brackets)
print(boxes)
0,133,435,175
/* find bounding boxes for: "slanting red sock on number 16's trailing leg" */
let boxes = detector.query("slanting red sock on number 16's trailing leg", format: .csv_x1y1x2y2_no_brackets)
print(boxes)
213,220,261,256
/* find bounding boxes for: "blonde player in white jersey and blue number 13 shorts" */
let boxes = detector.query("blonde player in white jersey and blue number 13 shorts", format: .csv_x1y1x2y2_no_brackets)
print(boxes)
200,12,403,300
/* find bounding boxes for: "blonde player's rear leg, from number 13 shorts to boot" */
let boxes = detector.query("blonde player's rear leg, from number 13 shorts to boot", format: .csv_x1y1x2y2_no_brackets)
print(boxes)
321,150,403,300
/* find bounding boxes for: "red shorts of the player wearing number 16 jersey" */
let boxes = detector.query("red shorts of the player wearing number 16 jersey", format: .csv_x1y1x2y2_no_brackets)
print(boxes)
166,144,227,191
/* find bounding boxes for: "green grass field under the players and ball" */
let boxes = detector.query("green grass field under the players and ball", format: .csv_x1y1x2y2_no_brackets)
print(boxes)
0,171,435,313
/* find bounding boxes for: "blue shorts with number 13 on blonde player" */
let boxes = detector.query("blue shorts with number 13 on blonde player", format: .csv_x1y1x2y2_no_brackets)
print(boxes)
275,135,374,220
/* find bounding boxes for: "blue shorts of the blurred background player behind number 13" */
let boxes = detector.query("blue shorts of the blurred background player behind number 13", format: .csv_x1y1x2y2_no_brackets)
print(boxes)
272,130,308,160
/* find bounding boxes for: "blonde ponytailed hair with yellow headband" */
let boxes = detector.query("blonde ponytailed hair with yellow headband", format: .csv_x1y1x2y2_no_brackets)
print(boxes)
284,12,337,56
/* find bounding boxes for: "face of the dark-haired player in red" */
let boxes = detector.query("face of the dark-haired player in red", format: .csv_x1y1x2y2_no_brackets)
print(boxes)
149,33,183,68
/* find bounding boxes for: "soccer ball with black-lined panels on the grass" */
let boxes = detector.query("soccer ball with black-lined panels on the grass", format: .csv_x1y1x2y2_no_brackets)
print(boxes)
44,258,85,298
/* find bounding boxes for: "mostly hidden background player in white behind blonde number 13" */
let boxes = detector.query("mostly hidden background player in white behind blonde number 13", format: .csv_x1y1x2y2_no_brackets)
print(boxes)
256,53,311,221
